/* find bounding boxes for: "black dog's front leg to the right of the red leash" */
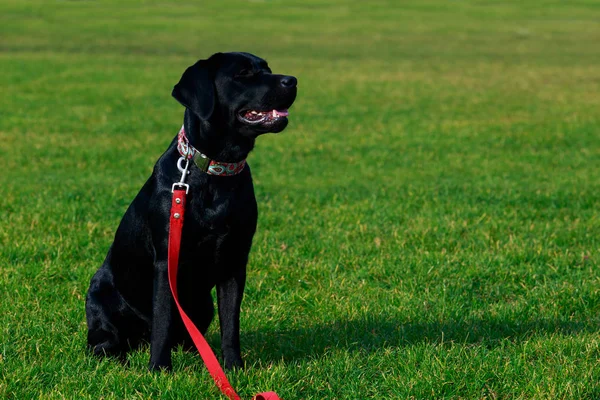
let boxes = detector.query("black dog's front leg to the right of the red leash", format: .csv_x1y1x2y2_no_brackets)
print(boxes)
217,270,246,369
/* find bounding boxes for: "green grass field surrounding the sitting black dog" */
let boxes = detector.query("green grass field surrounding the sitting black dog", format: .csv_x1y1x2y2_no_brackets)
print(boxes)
0,0,600,400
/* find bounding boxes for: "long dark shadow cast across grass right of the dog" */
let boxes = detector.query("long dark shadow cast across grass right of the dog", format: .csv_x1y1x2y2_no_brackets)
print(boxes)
242,320,600,363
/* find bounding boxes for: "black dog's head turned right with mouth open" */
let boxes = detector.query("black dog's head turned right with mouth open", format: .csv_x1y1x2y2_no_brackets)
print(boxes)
172,53,297,136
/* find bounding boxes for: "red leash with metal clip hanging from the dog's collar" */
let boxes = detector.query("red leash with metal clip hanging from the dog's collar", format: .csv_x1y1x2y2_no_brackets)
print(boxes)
168,188,280,400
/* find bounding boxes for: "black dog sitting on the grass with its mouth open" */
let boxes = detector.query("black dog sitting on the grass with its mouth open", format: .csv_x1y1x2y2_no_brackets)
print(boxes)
86,53,297,369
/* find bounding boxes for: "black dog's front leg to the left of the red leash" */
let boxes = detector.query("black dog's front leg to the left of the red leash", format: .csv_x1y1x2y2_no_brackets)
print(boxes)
149,254,175,370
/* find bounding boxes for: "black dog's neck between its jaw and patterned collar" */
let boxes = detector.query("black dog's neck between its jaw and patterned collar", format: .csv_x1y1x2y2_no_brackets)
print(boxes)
183,110,255,163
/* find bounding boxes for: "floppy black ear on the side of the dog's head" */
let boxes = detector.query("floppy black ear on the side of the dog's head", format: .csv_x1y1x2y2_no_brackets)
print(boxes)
171,53,223,120
